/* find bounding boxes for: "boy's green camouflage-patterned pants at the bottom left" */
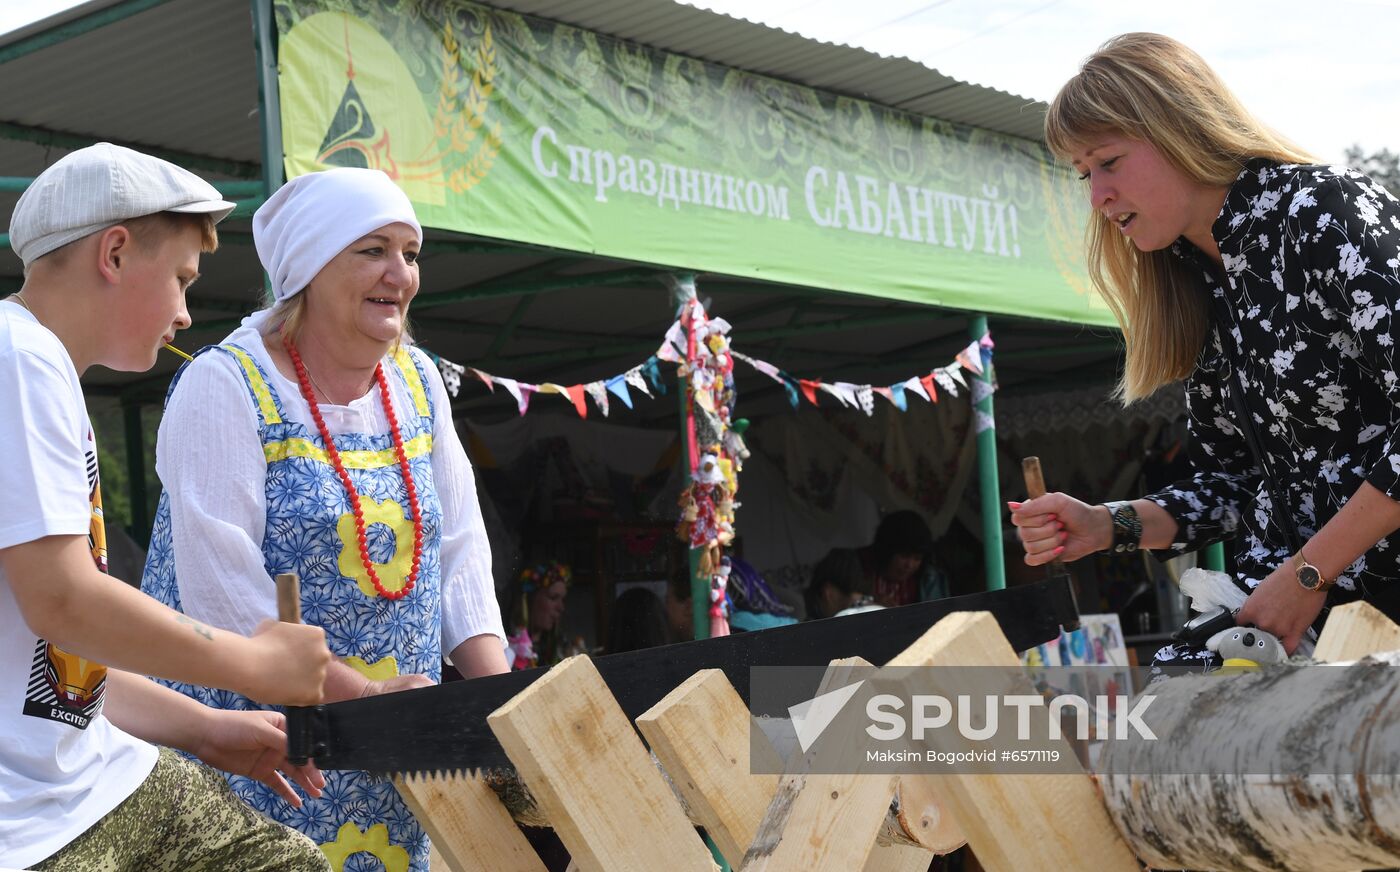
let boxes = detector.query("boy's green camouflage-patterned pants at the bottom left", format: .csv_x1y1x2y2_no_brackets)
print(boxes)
34,749,330,872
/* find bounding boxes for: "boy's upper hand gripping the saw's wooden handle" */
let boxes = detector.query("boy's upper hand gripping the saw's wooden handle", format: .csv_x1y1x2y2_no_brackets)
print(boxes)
242,620,330,705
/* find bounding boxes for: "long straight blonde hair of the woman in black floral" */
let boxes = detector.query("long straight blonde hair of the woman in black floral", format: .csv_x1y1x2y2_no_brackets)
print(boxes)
1046,34,1316,405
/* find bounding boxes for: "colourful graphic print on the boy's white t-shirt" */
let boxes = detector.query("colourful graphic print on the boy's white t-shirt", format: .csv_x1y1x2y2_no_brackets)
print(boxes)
24,430,106,729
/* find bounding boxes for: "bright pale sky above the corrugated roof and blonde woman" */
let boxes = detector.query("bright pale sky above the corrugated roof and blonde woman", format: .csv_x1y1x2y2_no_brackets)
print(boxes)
8,0,1400,161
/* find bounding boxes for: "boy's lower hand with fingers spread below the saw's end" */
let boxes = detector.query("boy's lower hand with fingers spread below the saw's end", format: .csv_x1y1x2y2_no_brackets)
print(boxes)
190,711,326,808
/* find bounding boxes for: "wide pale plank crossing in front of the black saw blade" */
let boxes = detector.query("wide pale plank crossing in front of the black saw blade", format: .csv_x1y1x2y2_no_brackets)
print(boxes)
487,655,714,872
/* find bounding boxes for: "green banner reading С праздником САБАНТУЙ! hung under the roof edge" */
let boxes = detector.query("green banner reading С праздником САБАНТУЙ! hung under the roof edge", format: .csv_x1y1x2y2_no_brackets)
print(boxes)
276,0,1113,323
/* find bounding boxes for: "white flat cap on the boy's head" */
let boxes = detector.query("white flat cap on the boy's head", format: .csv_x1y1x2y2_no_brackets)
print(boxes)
10,143,234,266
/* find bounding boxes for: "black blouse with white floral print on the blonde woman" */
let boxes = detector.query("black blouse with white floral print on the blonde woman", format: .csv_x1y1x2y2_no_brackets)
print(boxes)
1148,160,1400,617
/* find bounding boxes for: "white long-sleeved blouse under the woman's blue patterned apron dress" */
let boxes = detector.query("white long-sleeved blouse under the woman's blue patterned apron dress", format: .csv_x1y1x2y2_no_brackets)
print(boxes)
155,326,505,656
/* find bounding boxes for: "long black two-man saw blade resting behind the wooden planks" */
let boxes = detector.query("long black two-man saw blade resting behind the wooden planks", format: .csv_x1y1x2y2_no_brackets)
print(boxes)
287,578,1079,773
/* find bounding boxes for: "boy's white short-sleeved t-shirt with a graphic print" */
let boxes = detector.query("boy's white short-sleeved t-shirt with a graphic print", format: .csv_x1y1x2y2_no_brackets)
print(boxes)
0,302,158,868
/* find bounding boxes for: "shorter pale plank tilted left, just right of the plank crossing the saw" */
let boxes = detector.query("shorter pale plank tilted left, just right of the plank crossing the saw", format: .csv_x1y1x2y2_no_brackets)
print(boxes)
637,669,778,865
